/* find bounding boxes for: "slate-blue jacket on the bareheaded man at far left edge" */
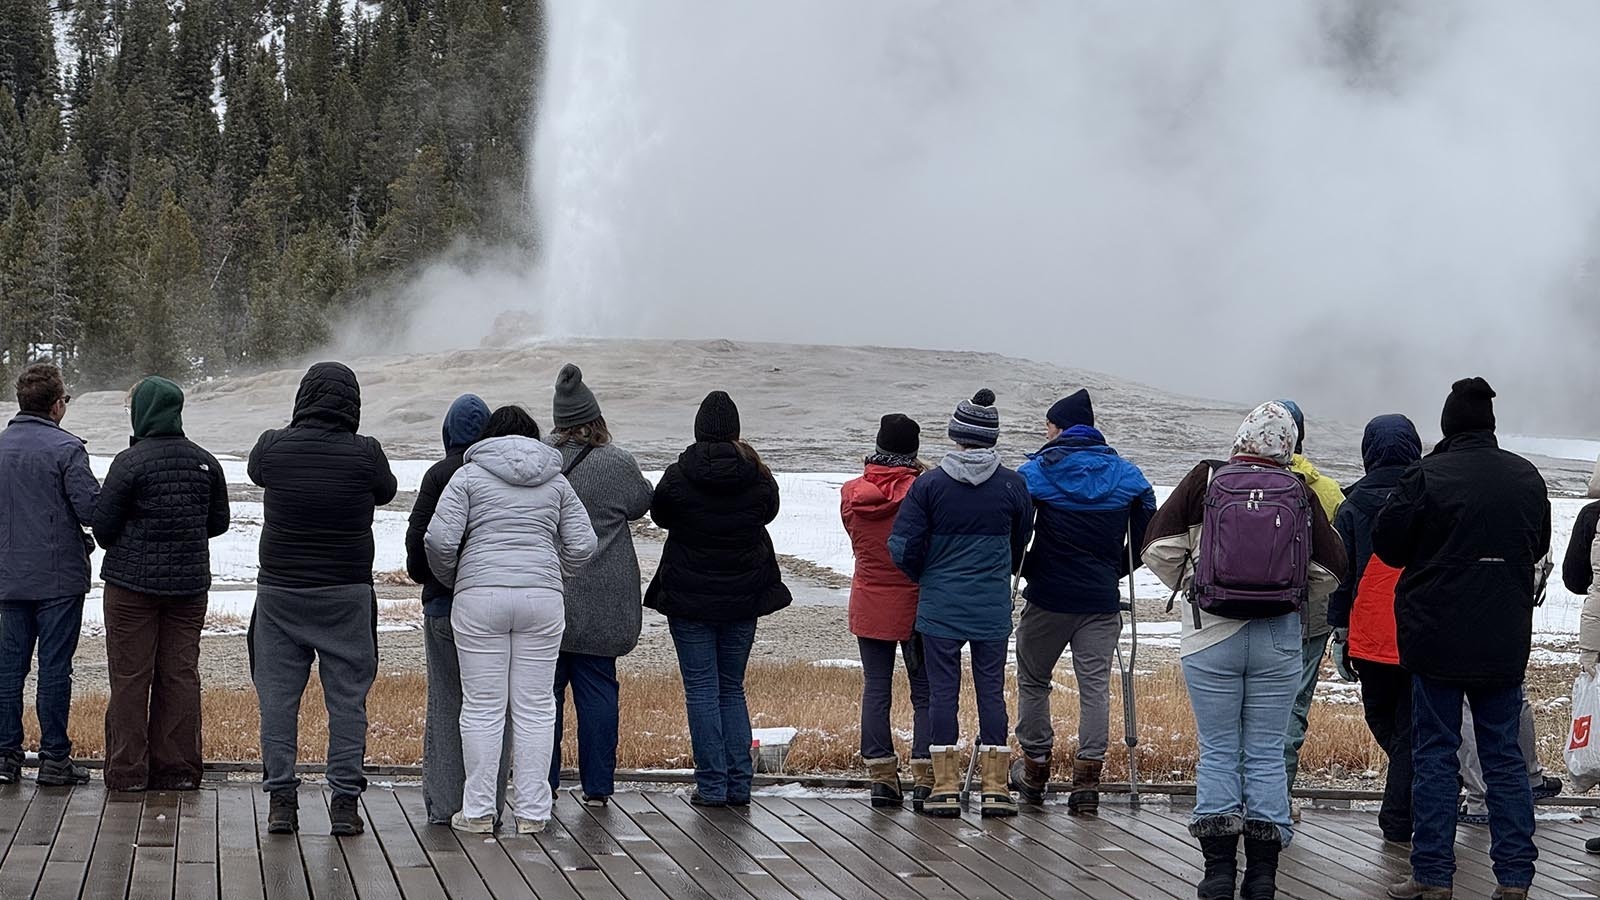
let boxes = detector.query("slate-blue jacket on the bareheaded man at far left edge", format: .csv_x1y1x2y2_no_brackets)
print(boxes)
0,413,99,601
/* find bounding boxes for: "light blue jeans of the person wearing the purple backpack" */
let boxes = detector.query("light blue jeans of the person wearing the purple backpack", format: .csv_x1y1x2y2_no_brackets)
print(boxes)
1182,612,1301,844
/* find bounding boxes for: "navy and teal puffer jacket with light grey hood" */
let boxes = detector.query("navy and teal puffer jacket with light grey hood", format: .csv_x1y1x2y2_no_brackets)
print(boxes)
890,450,1034,641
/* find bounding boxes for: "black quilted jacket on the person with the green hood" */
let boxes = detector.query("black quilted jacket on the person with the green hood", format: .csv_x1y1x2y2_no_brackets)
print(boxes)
94,436,229,597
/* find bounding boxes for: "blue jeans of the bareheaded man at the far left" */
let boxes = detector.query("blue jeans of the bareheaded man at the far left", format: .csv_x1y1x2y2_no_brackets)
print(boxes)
0,596,83,761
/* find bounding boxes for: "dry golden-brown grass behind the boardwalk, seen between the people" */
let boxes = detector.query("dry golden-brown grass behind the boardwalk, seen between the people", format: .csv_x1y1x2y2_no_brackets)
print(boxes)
29,663,1401,780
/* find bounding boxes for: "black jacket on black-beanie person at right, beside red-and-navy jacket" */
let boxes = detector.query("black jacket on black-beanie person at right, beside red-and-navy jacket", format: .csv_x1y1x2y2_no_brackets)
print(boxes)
1373,431,1550,687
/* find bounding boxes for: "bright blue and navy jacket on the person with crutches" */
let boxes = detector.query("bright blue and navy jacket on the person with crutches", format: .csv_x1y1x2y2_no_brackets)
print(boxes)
1018,424,1155,613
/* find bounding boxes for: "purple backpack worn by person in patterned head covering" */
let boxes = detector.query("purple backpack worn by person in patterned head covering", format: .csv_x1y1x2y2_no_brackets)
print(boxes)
1189,463,1315,628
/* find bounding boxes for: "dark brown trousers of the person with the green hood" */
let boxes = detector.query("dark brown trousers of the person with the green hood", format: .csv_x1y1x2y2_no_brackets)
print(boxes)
106,585,206,791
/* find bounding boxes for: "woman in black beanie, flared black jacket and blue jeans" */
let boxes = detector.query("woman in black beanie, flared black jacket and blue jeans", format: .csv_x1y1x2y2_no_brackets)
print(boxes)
645,391,792,806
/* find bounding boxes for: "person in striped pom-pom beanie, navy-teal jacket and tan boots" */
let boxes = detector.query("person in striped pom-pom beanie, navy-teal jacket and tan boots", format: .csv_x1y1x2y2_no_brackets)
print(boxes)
890,388,1034,818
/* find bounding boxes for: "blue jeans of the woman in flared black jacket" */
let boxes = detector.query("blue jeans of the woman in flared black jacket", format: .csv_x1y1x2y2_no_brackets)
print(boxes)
667,617,755,801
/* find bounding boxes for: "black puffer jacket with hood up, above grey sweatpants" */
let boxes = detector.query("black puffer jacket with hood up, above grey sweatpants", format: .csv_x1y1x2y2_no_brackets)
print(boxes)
250,362,397,588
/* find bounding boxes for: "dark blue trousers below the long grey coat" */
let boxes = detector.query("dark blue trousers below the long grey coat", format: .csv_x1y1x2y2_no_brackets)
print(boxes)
550,653,618,798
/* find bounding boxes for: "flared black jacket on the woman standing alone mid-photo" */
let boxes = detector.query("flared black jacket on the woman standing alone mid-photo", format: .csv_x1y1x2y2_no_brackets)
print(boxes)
645,442,792,621
